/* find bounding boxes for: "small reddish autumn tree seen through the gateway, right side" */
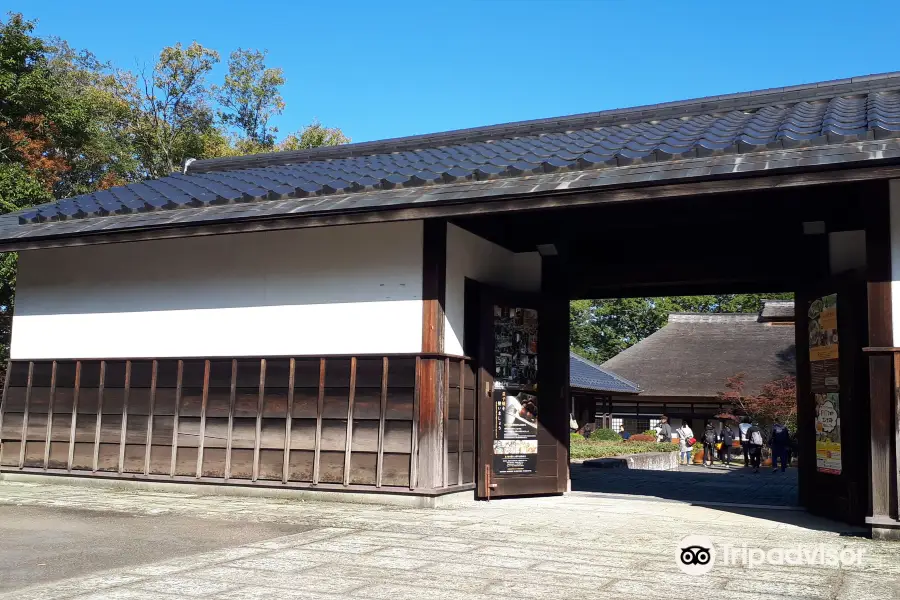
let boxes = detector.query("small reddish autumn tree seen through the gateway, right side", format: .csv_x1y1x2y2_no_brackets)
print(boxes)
719,373,797,436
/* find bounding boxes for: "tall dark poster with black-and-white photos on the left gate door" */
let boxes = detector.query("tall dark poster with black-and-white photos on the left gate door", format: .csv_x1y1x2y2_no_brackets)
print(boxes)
491,306,538,475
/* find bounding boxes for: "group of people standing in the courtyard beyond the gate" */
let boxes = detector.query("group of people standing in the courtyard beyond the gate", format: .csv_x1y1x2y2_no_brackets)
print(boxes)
672,417,793,473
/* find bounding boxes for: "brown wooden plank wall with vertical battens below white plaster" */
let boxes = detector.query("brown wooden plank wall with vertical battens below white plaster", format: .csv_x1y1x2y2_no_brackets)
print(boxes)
0,356,475,491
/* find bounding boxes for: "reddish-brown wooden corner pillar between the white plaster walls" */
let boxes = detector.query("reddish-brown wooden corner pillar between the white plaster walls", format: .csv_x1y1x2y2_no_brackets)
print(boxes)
420,220,447,489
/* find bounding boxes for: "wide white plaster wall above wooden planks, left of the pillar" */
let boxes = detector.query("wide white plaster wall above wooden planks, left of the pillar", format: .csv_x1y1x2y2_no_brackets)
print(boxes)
11,221,422,359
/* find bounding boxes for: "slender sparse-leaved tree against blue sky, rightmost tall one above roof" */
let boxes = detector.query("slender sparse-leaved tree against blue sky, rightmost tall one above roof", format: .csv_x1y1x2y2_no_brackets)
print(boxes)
215,48,284,151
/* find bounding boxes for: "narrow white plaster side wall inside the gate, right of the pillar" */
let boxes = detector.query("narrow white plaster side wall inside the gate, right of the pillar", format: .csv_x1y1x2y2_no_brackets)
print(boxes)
444,225,541,354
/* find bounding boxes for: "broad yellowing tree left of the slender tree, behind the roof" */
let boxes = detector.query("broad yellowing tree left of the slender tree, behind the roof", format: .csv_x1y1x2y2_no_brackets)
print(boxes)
117,42,219,177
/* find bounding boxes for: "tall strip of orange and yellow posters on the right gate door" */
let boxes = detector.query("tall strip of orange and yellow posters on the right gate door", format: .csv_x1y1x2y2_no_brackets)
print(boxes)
808,294,841,475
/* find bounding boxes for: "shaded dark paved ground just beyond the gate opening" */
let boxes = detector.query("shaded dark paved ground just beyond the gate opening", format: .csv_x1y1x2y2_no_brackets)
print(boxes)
572,463,797,506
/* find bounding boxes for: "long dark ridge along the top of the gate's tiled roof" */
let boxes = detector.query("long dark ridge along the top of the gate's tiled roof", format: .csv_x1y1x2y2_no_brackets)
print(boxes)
184,71,900,173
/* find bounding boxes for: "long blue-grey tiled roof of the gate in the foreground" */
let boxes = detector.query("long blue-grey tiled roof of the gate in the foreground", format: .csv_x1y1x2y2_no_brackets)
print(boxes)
0,74,900,246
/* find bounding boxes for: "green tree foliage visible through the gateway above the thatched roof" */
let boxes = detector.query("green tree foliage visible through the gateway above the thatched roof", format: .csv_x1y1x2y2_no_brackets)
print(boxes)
569,294,793,362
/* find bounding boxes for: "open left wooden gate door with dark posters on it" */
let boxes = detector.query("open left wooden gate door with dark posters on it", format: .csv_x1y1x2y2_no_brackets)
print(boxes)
476,286,568,499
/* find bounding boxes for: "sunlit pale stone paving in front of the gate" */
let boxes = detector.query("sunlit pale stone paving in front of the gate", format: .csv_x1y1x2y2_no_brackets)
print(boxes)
0,482,900,600
